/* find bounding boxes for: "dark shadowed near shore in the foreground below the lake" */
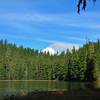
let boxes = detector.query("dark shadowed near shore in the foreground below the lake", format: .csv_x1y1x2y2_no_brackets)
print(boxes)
4,89,100,100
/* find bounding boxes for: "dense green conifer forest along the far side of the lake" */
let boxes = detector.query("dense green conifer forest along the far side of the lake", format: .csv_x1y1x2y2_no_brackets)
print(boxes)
0,40,100,81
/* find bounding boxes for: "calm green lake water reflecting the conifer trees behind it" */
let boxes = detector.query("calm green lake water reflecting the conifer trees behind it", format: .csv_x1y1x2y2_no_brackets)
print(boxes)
0,81,98,96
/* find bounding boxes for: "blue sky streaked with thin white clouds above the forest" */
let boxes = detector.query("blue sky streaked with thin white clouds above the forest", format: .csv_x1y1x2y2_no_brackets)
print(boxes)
0,0,100,50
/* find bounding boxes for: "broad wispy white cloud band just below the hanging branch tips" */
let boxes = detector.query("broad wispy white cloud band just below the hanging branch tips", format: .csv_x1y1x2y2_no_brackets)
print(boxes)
0,12,100,29
